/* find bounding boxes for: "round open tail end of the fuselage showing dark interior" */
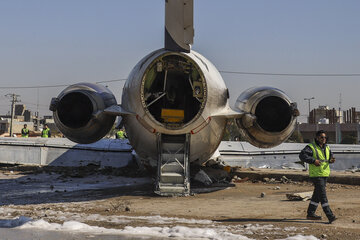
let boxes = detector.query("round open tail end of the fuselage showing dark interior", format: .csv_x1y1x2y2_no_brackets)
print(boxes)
141,53,206,129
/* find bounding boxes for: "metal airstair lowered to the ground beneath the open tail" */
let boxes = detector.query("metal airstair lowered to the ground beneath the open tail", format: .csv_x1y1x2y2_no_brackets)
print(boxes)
155,133,190,196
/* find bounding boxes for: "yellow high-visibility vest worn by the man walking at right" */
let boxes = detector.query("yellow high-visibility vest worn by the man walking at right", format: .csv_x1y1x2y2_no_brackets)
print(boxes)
308,143,330,177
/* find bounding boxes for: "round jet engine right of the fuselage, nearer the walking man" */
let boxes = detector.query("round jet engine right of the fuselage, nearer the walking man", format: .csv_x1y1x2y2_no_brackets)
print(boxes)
235,87,299,148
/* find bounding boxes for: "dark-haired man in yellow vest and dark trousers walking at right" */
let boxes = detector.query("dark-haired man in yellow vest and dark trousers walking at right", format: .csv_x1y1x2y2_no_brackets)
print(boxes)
299,130,337,223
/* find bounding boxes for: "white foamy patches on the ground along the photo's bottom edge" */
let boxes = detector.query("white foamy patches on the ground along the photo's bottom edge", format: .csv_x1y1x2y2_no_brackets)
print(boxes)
0,215,317,240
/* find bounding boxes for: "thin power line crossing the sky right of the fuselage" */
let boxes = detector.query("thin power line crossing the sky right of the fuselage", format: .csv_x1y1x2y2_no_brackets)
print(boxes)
219,70,360,77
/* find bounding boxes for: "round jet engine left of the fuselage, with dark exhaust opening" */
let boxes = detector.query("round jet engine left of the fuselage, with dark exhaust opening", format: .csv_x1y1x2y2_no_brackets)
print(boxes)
50,83,117,143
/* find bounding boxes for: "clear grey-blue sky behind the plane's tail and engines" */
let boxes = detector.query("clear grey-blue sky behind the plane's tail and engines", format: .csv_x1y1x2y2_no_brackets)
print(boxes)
0,0,360,121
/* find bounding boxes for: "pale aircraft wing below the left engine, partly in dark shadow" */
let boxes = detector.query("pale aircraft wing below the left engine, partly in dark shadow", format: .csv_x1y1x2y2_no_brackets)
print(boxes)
0,138,132,167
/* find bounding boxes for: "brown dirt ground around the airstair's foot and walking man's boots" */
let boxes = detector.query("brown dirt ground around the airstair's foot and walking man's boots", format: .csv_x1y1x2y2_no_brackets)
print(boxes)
2,165,360,240
